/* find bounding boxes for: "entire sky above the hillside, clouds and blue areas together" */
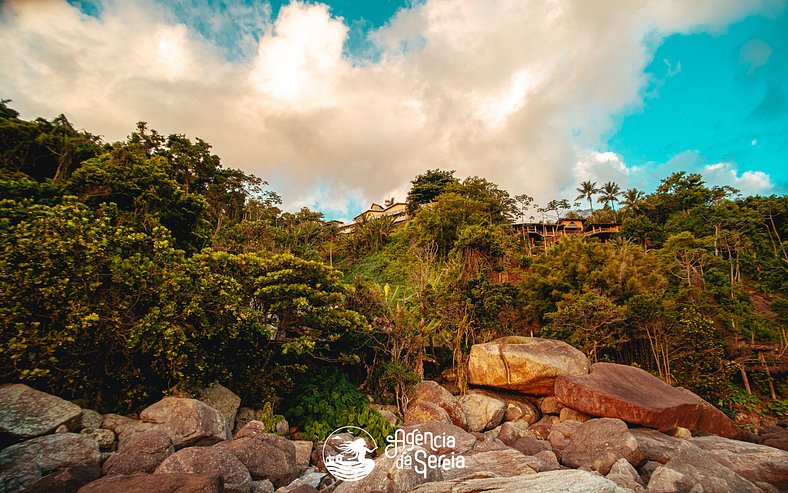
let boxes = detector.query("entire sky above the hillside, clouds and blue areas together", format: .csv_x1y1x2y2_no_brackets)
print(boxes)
0,0,788,219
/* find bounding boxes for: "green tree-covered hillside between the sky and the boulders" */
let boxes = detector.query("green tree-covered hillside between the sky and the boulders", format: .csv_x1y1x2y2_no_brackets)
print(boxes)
0,101,788,430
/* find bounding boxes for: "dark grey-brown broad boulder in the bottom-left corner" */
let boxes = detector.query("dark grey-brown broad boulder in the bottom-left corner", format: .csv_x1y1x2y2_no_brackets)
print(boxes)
0,433,101,492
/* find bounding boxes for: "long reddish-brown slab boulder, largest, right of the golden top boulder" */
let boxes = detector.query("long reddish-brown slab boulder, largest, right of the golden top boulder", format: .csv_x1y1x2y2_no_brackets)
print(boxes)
555,363,742,438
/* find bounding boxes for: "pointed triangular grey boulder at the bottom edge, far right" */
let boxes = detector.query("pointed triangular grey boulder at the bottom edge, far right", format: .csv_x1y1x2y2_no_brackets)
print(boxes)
648,440,761,493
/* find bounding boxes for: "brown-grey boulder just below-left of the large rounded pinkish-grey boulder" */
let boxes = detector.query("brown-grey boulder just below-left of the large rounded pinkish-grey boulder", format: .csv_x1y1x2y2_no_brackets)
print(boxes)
102,430,175,475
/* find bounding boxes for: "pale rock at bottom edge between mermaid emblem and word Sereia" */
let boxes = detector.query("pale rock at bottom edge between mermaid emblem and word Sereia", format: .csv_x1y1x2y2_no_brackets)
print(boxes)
334,447,443,493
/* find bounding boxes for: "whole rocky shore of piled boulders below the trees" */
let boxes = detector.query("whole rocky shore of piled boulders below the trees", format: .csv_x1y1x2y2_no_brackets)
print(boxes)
0,337,788,493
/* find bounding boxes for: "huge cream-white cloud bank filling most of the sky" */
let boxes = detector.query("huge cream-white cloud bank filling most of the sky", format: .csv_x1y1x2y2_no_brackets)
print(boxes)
0,0,771,217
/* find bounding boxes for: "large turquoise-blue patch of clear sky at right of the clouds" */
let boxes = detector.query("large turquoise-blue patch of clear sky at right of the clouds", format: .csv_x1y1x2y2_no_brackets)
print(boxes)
607,10,788,193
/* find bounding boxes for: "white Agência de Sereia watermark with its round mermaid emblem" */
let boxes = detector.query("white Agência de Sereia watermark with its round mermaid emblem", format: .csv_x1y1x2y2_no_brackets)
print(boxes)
323,426,465,482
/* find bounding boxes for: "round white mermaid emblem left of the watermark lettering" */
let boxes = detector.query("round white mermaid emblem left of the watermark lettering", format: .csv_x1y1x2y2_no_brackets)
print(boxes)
323,426,378,482
